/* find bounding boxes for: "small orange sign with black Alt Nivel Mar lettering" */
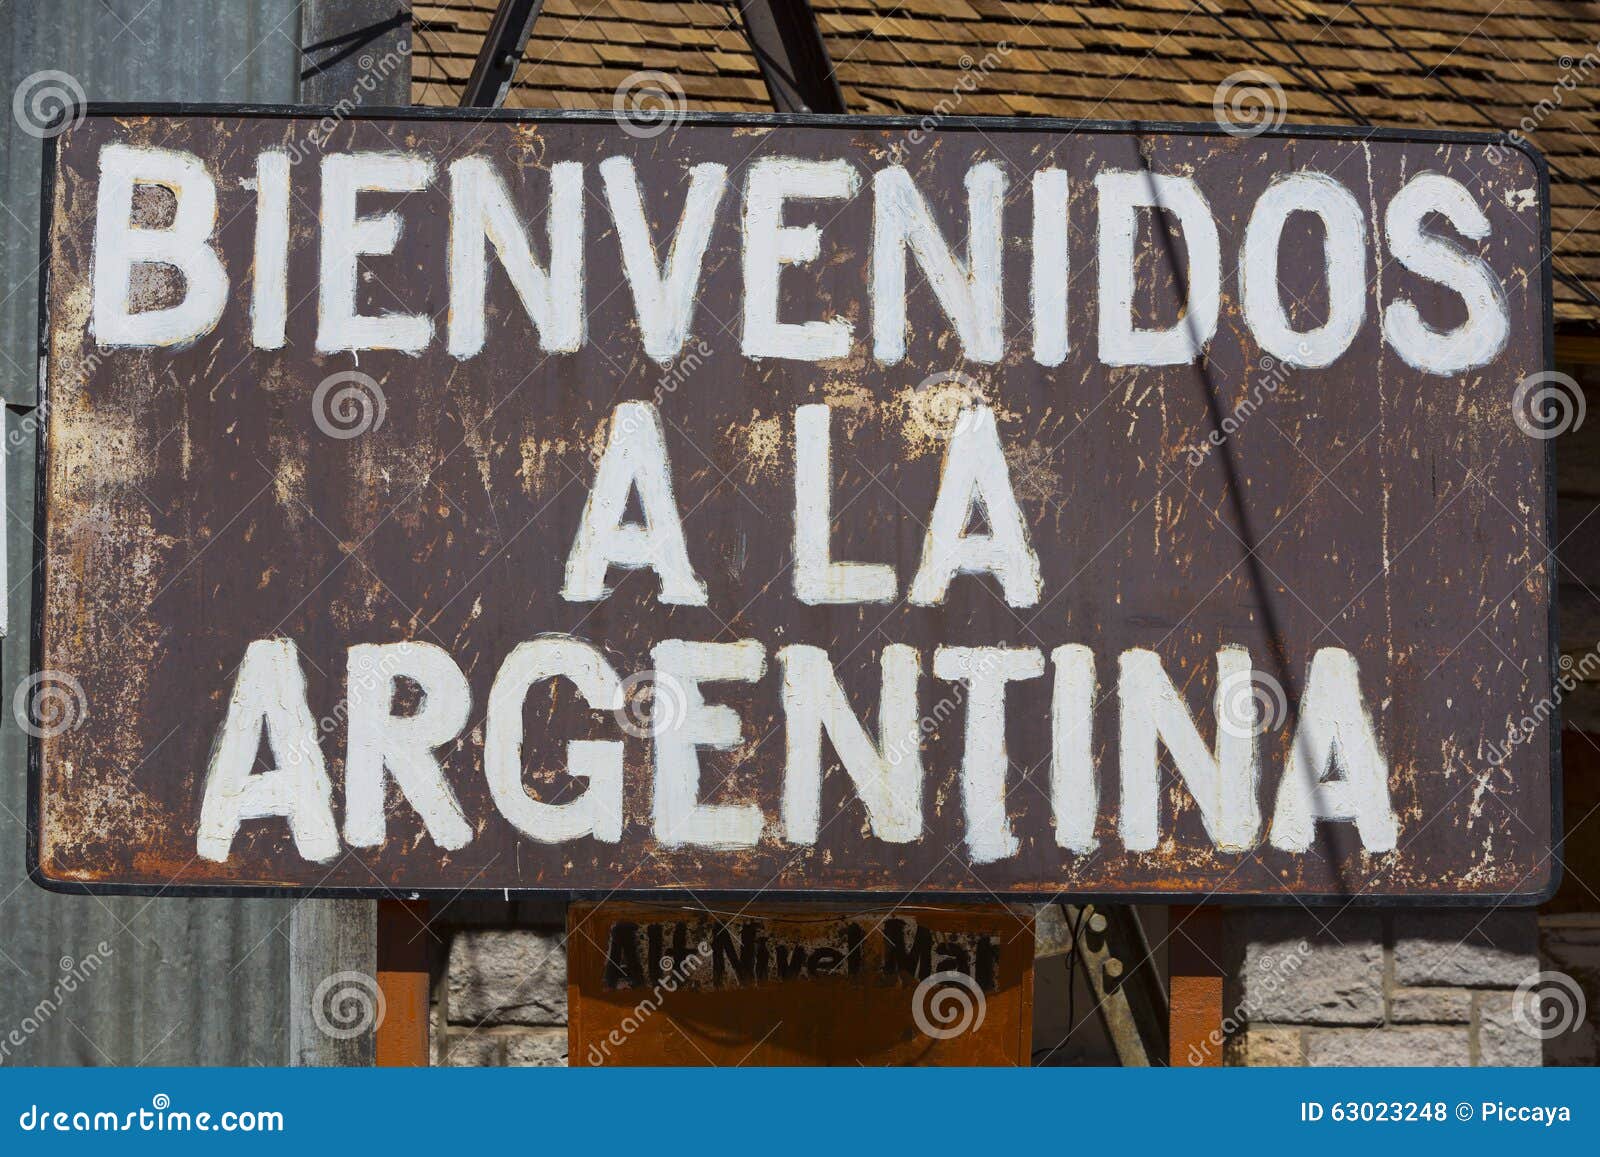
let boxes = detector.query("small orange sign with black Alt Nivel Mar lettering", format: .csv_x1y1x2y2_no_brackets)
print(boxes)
568,903,1034,1066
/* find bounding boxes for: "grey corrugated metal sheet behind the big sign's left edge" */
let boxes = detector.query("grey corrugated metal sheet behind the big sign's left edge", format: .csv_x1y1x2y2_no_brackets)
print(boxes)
0,0,299,1064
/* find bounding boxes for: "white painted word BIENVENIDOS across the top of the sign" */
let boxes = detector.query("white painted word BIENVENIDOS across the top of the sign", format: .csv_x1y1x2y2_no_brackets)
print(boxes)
91,144,1510,374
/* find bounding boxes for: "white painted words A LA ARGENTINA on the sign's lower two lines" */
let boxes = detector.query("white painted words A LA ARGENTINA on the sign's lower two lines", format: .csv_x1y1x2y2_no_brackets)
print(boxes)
197,393,1395,863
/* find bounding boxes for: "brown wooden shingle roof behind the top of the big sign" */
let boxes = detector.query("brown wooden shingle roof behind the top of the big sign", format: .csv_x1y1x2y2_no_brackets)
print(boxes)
413,0,1600,326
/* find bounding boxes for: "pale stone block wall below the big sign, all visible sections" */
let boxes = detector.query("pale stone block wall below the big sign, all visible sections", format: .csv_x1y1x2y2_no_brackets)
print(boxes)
419,901,1600,1066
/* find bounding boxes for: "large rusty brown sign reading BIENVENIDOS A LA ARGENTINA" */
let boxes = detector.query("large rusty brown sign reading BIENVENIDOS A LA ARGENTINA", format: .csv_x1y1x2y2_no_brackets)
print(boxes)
30,107,1562,901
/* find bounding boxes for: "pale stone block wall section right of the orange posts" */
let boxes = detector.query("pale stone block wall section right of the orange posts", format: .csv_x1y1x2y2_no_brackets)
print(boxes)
1226,909,1546,1066
